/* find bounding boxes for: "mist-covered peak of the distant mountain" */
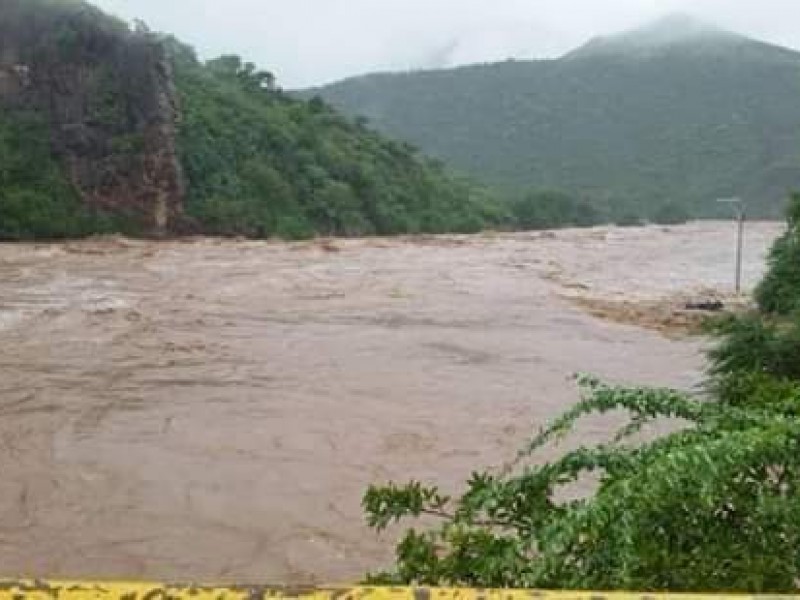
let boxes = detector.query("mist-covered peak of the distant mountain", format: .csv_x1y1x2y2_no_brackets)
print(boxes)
567,13,747,58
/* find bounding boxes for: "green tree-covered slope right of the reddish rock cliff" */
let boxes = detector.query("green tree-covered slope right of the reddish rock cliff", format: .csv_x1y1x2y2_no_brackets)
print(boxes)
169,45,502,238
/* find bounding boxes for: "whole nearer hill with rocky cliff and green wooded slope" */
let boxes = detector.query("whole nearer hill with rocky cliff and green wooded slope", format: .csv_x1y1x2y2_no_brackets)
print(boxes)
0,0,502,239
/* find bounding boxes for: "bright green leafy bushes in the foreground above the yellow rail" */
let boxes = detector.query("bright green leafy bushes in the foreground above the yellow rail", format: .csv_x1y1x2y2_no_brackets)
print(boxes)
364,197,800,592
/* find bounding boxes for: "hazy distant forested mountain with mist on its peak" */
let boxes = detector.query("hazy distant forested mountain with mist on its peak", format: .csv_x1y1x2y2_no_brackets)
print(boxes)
303,16,800,216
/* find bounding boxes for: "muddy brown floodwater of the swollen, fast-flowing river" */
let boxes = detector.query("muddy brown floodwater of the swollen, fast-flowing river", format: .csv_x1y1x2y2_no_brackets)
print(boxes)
0,223,781,583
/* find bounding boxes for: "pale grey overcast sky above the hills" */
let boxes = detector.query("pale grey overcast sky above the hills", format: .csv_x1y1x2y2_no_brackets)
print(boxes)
94,0,800,88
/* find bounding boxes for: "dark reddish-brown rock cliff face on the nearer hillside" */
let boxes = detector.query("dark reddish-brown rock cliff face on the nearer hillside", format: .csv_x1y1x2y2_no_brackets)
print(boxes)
0,0,185,235
